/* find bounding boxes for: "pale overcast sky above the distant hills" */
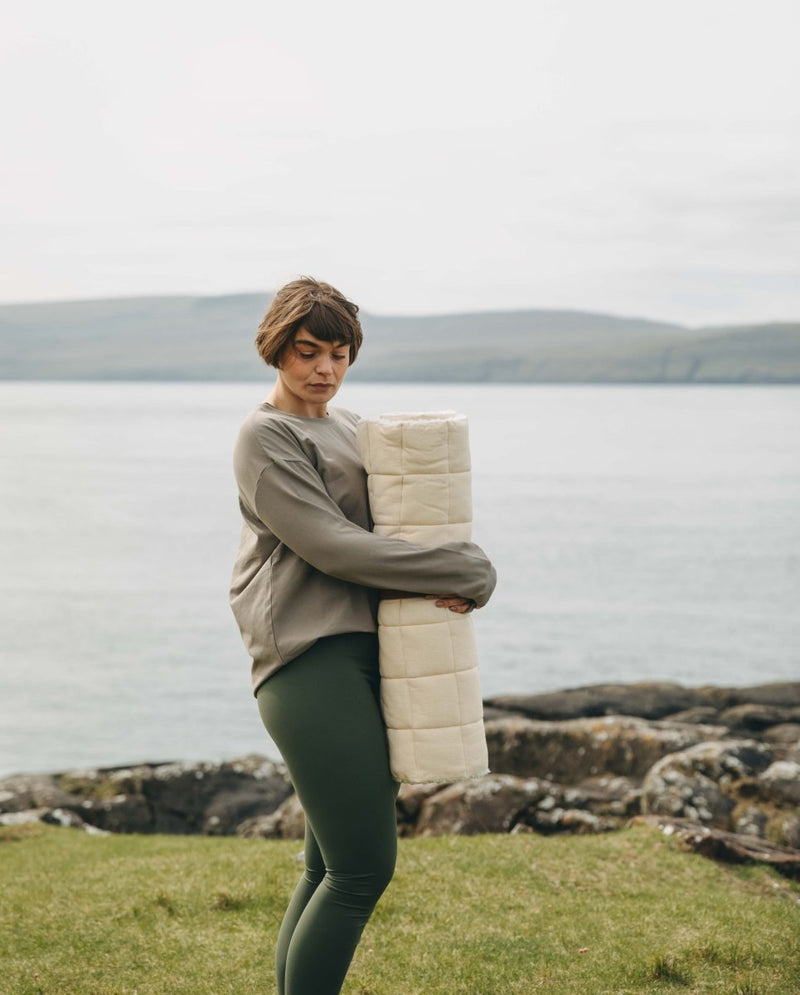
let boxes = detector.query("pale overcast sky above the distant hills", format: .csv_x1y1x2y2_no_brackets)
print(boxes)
0,0,800,325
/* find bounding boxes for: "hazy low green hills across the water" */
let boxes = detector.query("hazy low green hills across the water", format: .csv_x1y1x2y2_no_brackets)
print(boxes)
0,294,800,383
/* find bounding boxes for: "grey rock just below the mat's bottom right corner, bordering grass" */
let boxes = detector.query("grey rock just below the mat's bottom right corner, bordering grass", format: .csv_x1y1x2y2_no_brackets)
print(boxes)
415,774,557,836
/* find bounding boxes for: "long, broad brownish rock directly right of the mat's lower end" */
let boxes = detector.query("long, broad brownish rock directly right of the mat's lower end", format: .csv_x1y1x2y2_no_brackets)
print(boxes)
486,716,725,785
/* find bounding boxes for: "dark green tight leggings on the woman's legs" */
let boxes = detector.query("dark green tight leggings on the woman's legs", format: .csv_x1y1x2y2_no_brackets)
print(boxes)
257,632,397,995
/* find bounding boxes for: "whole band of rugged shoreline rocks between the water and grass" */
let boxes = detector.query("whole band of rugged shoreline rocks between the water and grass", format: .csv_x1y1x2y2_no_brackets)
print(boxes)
0,682,800,877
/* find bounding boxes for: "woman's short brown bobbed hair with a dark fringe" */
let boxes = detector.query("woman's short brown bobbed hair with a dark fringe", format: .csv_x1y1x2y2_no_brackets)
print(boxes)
256,276,363,366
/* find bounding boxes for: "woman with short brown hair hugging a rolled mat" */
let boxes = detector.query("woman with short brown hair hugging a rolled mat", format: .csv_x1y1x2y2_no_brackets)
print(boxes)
231,277,495,995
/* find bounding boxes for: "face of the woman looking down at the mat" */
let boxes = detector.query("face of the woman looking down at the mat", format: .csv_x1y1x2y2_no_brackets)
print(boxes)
278,328,350,414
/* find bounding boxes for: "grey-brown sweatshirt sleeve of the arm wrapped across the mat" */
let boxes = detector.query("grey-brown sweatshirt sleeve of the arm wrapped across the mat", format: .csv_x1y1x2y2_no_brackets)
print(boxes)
253,459,496,607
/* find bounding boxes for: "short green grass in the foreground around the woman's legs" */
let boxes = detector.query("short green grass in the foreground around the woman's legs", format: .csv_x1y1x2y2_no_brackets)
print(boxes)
0,826,800,995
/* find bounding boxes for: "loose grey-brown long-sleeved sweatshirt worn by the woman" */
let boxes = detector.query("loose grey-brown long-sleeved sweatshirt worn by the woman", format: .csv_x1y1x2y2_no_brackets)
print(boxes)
230,402,496,693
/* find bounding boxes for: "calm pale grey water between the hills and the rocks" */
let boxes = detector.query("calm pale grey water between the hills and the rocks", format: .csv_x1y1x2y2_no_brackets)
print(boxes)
0,383,800,773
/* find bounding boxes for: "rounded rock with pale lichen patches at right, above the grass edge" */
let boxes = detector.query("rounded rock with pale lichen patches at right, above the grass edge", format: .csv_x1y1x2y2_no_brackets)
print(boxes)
642,740,772,829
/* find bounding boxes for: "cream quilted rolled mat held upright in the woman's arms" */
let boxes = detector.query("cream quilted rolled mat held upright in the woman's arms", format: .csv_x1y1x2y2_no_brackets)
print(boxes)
357,411,489,784
